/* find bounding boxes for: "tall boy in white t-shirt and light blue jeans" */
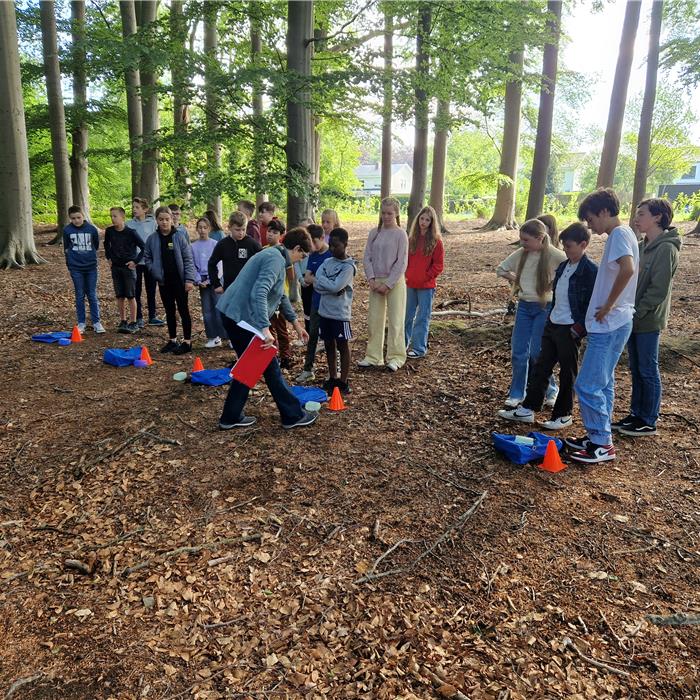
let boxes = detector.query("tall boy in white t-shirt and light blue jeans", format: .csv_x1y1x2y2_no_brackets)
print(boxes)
565,188,639,464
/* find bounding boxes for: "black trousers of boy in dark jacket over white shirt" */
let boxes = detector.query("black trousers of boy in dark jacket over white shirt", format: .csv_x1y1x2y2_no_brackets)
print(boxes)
523,321,580,420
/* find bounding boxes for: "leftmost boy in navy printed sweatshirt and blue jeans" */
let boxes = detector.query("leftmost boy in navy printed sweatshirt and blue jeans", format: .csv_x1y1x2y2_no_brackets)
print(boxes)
63,204,105,333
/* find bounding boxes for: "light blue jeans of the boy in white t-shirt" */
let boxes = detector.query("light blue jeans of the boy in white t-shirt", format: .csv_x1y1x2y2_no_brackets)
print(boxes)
576,321,632,445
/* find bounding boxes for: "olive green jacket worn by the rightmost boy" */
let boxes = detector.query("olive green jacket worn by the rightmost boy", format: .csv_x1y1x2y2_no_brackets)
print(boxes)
632,228,681,333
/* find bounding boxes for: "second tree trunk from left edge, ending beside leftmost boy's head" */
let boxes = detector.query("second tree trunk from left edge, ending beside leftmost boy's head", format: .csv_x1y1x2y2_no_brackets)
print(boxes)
38,0,73,242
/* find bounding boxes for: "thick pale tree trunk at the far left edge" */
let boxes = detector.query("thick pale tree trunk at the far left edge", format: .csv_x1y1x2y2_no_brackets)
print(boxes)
0,2,42,269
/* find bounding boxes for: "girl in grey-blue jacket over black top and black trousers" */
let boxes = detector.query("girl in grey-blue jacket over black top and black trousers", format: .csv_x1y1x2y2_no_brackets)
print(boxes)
144,207,195,355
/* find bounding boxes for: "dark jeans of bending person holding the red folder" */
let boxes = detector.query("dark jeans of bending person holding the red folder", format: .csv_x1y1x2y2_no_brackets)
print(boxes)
220,315,304,425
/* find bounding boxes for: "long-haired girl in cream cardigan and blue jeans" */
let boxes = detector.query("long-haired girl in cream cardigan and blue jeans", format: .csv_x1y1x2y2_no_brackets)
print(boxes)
496,219,566,408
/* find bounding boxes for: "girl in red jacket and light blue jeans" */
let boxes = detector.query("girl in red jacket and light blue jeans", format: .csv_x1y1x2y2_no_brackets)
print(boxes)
405,202,445,357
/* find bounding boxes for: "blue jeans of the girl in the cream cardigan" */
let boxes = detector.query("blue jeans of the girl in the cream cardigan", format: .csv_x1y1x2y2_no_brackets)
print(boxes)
508,301,557,401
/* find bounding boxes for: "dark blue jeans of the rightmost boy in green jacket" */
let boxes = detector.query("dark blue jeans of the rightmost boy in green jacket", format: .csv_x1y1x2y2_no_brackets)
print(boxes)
627,331,661,426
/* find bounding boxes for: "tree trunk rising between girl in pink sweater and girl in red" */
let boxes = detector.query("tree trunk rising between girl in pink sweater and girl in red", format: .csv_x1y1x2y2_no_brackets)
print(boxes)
406,2,432,227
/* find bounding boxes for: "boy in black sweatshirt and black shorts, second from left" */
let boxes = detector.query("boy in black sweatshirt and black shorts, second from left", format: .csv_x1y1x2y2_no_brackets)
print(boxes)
105,207,143,333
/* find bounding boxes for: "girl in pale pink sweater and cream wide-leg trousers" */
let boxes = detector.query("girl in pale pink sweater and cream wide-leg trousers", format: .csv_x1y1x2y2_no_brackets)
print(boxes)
357,197,408,372
